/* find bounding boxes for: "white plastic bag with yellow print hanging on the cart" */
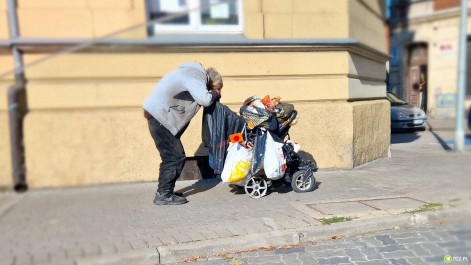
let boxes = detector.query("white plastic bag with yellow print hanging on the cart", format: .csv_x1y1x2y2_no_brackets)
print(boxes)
221,143,252,183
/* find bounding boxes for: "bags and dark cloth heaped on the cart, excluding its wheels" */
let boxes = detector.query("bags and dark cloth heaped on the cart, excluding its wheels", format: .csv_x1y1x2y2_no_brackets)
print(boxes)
203,95,299,183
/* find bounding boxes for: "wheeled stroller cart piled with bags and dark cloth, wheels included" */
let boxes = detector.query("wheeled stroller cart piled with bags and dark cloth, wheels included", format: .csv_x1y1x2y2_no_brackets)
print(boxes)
203,96,316,198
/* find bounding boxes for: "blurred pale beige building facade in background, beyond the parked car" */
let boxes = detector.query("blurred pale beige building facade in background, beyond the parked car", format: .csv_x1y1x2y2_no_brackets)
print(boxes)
391,6,471,119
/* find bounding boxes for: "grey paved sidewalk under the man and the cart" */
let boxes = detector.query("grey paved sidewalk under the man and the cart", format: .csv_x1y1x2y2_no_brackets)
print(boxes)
0,132,471,265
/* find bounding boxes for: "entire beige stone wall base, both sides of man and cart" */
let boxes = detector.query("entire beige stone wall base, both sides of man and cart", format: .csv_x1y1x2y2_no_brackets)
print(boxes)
15,100,390,188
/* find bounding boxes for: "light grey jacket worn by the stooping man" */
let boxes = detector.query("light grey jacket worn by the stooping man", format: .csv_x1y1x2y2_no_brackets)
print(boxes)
143,62,218,135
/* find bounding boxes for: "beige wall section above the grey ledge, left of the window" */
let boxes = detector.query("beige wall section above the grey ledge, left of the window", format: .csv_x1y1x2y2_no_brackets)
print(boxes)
17,0,145,38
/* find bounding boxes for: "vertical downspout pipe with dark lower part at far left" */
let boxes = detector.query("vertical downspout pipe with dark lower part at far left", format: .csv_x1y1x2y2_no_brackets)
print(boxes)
7,0,28,192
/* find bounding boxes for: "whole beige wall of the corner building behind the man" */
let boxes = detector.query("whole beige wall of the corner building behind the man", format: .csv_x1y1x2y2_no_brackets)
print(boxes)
0,0,389,187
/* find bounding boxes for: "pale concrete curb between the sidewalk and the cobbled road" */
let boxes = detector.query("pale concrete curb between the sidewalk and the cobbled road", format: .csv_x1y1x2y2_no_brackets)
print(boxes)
76,201,471,265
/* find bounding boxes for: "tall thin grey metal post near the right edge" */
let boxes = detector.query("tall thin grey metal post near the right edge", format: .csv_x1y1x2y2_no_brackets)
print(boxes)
454,0,468,152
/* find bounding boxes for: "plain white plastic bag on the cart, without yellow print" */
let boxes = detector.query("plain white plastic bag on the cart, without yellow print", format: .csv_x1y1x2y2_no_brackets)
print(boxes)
263,133,286,180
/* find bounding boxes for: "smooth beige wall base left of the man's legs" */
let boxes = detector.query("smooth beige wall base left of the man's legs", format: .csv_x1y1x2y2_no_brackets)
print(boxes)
25,109,156,187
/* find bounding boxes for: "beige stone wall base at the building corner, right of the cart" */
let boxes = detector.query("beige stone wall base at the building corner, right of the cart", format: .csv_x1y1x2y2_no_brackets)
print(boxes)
290,100,390,169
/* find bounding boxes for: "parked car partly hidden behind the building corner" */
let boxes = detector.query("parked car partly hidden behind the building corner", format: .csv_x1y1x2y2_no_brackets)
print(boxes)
387,92,427,130
